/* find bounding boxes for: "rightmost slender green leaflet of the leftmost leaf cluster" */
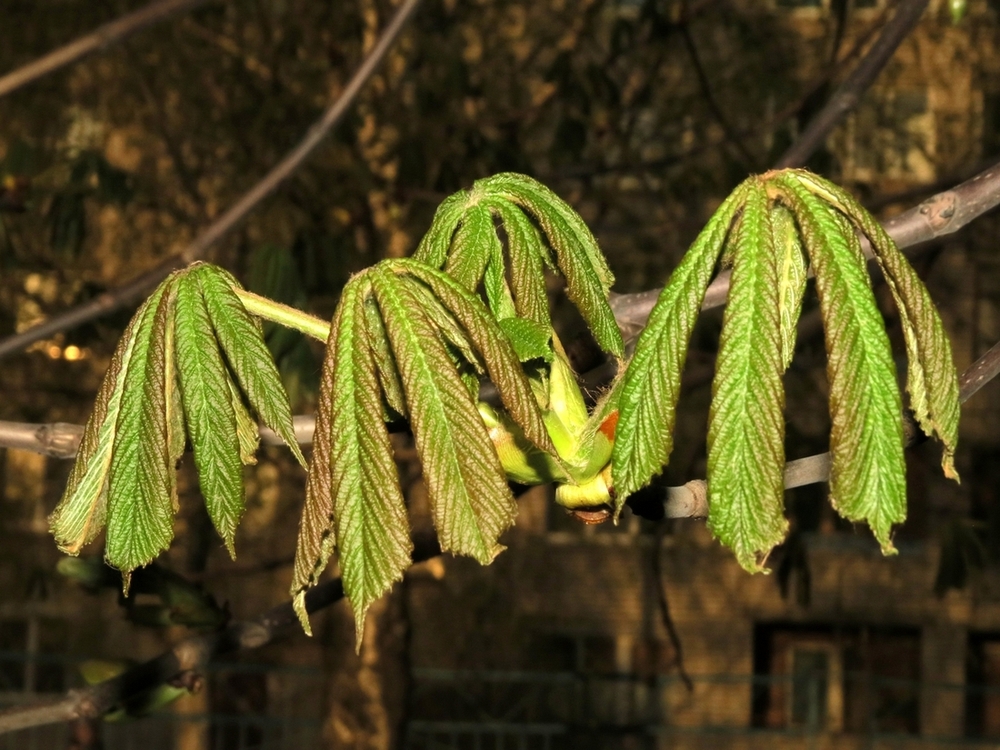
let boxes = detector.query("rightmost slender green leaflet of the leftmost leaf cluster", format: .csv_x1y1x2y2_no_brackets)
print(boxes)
190,264,306,466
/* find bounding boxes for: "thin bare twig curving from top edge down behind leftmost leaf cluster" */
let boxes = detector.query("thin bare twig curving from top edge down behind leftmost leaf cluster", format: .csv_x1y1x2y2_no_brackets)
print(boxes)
0,0,420,358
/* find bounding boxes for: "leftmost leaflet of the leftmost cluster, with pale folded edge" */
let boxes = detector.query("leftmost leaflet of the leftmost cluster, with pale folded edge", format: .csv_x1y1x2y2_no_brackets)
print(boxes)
49,290,158,555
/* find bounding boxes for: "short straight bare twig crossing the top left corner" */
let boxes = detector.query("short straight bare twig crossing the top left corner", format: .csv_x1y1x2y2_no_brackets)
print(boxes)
0,0,206,96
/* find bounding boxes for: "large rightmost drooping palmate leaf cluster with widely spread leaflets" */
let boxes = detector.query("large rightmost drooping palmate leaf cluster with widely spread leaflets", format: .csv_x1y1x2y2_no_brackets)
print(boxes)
613,170,959,570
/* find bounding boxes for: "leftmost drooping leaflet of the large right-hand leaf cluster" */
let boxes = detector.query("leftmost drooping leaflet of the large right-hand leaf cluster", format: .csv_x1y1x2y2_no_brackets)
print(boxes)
612,183,747,508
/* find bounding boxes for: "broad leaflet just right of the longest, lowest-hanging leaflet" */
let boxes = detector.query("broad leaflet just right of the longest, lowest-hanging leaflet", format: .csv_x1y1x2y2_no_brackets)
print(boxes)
370,264,517,564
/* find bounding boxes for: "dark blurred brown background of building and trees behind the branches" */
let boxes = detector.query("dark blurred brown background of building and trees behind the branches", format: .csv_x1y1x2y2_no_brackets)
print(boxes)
0,0,1000,750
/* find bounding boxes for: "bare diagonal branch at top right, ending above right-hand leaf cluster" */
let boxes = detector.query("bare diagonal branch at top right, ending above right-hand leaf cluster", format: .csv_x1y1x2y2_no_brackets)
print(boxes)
775,0,928,169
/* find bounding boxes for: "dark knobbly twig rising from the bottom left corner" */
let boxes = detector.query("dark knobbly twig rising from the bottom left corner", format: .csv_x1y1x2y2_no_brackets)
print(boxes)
0,536,441,734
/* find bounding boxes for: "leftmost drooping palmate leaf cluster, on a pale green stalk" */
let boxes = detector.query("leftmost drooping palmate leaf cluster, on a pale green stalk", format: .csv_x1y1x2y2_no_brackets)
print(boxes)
50,263,305,589
